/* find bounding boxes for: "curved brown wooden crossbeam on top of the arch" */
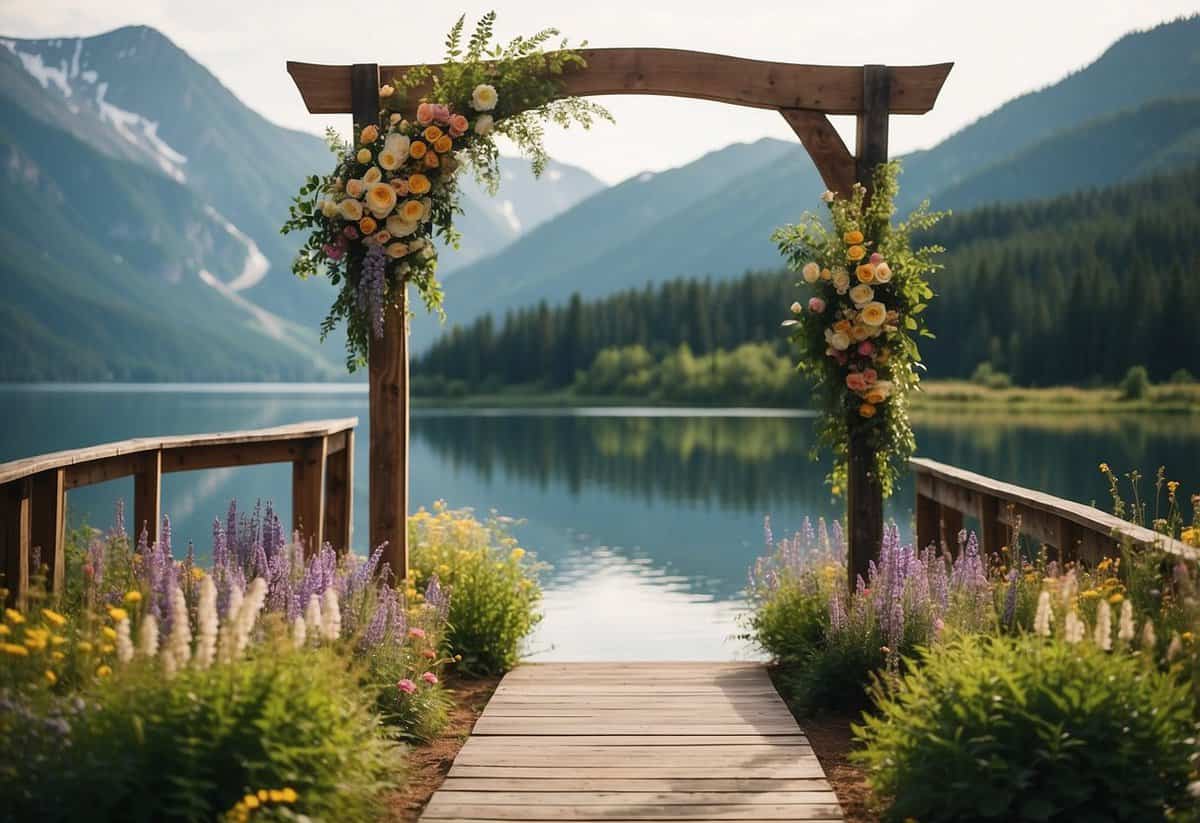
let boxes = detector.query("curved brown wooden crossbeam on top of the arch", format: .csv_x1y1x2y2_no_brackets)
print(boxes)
287,48,954,114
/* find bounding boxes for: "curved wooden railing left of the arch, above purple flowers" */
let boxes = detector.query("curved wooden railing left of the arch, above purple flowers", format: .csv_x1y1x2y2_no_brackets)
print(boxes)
0,417,359,599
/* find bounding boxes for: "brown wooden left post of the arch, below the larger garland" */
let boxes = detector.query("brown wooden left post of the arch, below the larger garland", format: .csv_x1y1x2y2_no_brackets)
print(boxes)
350,64,408,579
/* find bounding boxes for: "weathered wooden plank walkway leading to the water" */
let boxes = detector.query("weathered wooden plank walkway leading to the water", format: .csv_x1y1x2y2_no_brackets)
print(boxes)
421,663,841,822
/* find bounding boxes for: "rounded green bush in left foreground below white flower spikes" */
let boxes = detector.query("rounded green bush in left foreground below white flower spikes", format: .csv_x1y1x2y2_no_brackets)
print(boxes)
23,644,401,822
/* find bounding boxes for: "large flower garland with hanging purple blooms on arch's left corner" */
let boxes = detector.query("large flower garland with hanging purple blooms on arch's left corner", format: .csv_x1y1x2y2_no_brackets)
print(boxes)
283,12,612,372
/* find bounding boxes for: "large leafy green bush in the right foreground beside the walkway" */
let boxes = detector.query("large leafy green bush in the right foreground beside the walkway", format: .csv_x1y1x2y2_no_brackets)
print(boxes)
853,636,1195,823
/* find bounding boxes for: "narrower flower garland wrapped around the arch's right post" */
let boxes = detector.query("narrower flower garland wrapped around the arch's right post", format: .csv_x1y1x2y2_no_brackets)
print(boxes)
773,163,944,495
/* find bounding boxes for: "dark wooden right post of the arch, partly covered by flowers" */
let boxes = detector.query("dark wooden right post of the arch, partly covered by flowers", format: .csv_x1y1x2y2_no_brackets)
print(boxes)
846,66,892,591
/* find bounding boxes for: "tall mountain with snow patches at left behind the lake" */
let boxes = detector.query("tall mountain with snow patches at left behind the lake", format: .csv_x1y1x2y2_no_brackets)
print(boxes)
0,26,601,379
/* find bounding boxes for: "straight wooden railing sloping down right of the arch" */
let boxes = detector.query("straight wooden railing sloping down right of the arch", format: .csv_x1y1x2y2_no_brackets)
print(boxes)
908,458,1200,563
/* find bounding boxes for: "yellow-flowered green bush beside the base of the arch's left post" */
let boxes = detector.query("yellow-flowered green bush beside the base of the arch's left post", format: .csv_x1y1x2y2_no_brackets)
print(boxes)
409,504,541,675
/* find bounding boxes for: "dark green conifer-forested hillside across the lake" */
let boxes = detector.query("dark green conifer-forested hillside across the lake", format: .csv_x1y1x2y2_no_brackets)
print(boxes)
414,168,1200,392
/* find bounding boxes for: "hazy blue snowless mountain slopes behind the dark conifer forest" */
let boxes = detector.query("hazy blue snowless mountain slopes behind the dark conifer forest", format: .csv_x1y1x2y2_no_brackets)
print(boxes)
429,17,1200,349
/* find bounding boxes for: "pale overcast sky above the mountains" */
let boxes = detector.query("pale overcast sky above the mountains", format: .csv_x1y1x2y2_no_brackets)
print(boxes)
0,0,1200,182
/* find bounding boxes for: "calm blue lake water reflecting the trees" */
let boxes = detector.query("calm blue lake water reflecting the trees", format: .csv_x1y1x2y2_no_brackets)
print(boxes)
0,385,1200,659
